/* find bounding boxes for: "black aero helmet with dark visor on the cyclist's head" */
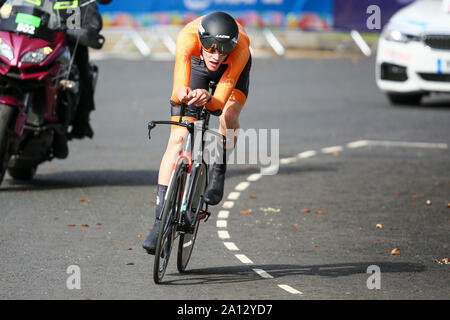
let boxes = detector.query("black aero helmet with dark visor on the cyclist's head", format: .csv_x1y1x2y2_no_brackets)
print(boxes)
198,11,239,54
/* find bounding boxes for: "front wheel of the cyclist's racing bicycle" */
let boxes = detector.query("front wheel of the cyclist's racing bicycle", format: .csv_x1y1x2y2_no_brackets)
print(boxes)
153,164,186,284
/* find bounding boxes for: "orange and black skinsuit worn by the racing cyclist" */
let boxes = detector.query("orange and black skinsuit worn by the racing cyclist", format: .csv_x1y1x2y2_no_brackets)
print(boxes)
170,17,251,121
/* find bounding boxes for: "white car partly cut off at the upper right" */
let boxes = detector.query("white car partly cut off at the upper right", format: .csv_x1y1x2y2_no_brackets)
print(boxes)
376,0,450,104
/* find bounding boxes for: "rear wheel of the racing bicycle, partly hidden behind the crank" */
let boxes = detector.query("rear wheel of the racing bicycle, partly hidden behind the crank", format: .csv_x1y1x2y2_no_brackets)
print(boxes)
177,163,207,272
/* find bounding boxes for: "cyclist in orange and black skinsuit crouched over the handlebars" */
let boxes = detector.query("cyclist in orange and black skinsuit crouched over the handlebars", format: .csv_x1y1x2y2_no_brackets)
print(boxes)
142,12,251,254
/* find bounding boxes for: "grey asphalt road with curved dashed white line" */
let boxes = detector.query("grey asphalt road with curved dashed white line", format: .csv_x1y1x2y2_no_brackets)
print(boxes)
0,57,450,300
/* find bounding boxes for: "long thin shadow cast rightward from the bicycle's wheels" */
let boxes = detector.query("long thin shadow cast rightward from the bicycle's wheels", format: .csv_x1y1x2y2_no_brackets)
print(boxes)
164,261,426,285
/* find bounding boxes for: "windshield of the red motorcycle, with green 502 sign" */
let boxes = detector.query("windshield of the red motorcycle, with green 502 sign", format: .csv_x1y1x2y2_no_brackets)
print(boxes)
0,0,79,41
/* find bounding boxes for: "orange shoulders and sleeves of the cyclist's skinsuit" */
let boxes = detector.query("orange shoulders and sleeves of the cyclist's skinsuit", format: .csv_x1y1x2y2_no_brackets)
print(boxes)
171,17,250,110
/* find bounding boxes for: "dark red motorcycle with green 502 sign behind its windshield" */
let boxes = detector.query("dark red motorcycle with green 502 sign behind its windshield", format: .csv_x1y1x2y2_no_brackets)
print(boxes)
0,0,111,184
